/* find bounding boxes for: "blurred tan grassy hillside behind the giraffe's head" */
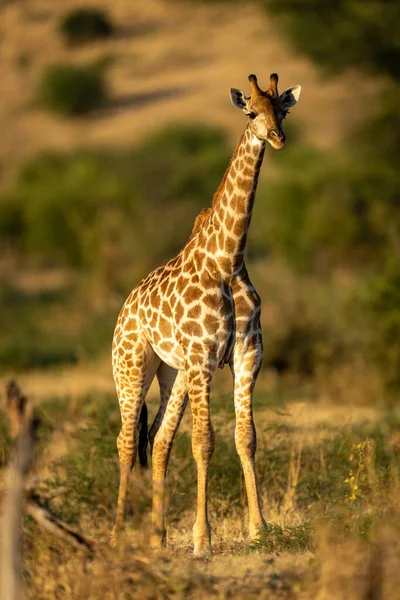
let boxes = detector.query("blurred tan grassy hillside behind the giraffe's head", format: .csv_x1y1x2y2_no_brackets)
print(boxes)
0,0,376,182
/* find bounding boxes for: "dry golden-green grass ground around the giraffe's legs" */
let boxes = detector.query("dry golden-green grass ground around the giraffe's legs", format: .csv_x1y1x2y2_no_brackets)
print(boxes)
1,376,400,600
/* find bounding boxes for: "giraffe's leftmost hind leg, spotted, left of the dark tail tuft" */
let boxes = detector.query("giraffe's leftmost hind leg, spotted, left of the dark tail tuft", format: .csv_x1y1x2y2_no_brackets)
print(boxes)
111,332,160,544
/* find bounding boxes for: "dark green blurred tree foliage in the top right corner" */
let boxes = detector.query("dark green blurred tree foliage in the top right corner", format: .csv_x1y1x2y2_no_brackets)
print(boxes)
262,0,400,80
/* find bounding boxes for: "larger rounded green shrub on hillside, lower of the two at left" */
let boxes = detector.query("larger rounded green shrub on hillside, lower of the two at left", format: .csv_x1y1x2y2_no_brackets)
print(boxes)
39,63,108,117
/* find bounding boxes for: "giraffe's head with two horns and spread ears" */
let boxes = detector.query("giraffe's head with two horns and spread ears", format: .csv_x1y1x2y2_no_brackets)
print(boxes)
230,73,301,150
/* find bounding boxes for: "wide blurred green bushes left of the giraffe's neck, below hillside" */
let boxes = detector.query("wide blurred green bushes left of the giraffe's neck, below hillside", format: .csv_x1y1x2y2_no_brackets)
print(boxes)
0,126,229,284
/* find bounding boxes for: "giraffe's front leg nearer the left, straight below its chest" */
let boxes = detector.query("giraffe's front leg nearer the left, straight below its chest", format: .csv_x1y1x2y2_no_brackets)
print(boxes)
187,368,215,556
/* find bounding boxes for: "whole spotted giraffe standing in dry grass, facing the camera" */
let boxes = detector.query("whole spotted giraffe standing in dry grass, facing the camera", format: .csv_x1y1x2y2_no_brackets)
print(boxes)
111,73,301,555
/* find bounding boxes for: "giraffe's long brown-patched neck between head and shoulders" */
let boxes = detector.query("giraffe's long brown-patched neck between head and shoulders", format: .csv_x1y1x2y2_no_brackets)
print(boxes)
207,124,265,281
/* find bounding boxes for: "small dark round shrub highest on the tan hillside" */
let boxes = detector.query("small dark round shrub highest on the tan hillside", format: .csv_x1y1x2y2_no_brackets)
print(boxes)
59,8,114,46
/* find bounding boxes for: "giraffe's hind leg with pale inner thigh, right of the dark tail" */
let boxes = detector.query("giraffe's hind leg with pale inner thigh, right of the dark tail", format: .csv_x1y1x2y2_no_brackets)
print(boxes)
150,365,188,548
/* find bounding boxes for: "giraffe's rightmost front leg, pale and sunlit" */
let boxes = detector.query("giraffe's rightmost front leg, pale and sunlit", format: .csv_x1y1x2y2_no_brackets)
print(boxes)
232,342,266,539
